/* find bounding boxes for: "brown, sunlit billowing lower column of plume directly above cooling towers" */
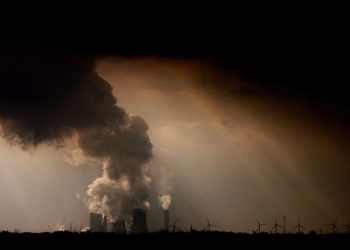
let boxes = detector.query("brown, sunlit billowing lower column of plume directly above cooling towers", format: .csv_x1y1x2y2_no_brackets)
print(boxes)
84,113,152,219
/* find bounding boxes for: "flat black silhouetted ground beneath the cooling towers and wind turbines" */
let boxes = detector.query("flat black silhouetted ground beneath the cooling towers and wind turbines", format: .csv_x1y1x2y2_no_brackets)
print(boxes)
0,232,350,249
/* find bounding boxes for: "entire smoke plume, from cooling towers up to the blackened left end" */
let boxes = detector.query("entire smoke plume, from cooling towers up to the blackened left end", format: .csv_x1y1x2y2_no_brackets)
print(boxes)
0,46,152,219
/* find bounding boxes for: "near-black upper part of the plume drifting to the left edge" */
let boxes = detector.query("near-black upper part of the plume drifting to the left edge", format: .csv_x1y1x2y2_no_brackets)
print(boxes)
0,47,125,146
